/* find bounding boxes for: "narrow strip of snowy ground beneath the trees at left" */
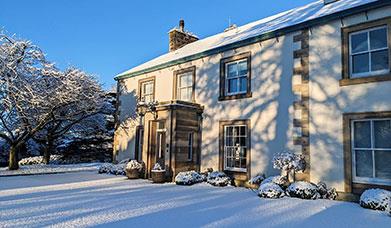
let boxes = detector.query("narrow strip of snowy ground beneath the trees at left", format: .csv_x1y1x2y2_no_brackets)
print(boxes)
0,163,102,177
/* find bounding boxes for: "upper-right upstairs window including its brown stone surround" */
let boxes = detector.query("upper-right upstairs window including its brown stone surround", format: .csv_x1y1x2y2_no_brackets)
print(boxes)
340,18,391,86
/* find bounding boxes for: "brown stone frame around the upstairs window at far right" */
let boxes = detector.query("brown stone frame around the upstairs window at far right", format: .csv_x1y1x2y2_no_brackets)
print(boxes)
339,17,391,86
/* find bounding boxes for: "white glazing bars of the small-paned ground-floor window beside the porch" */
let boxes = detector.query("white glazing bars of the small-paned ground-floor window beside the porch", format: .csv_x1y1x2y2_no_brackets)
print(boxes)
223,124,249,172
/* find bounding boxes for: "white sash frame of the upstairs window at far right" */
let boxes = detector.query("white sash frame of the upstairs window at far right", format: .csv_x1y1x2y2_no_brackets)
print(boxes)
349,25,390,78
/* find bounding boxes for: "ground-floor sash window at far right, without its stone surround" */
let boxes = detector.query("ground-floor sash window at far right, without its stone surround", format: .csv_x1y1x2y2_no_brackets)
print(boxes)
351,118,391,185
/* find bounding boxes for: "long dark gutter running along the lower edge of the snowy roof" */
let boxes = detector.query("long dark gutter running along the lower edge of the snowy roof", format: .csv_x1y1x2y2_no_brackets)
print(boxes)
114,0,391,81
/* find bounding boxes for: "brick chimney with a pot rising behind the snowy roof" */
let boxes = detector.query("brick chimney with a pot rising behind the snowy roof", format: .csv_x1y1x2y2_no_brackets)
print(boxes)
168,19,198,52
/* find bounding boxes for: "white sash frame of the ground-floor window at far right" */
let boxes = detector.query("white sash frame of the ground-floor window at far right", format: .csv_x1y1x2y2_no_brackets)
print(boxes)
350,118,391,185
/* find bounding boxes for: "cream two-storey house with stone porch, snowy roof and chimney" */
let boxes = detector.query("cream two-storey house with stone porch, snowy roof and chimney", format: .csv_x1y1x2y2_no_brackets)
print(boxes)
114,0,391,196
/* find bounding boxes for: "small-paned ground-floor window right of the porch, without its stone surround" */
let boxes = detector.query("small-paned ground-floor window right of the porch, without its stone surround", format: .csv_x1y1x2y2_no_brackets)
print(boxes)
224,125,248,172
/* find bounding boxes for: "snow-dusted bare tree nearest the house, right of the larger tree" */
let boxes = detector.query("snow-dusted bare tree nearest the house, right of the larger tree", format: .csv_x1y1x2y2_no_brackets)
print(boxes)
34,68,105,164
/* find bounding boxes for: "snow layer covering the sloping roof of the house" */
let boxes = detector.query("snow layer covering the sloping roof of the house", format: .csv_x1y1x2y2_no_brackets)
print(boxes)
116,0,379,77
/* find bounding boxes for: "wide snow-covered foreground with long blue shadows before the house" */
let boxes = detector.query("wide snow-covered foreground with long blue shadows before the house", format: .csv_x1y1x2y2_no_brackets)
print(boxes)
0,172,391,228
